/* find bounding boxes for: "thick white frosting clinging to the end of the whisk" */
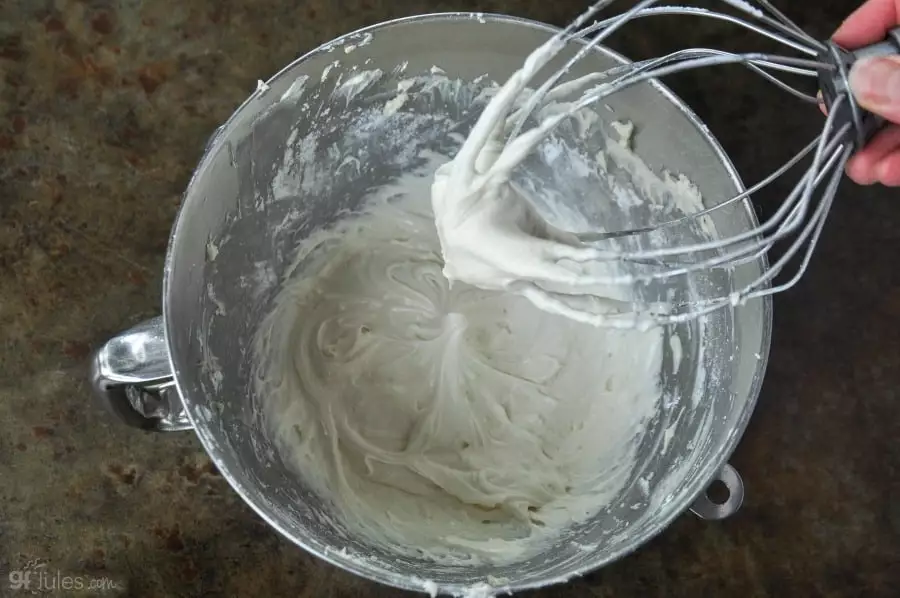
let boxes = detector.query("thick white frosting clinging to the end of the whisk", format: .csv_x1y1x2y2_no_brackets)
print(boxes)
431,32,652,328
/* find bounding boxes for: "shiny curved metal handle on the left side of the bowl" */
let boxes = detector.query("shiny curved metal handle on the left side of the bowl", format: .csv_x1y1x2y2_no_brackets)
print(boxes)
91,317,193,432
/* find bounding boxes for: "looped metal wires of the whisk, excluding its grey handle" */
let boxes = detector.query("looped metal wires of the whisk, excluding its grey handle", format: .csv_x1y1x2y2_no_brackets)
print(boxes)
478,0,859,325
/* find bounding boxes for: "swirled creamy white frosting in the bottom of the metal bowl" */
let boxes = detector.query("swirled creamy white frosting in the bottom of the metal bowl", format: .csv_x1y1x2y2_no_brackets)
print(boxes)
257,163,664,563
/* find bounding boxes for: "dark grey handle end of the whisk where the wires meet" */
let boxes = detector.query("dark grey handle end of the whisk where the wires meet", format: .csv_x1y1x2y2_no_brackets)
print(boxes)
819,27,900,148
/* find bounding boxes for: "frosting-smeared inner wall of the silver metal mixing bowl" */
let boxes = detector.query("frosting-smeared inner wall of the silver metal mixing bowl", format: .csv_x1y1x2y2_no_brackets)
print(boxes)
164,14,770,592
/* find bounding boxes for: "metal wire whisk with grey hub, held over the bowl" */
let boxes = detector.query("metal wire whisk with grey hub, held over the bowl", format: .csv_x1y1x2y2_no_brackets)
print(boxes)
454,0,900,324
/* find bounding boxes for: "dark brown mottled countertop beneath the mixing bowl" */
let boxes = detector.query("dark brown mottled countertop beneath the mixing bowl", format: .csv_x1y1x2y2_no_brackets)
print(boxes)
0,0,900,598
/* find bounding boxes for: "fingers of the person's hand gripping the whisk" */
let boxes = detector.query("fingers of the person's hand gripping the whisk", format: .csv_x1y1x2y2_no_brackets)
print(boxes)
833,0,900,186
